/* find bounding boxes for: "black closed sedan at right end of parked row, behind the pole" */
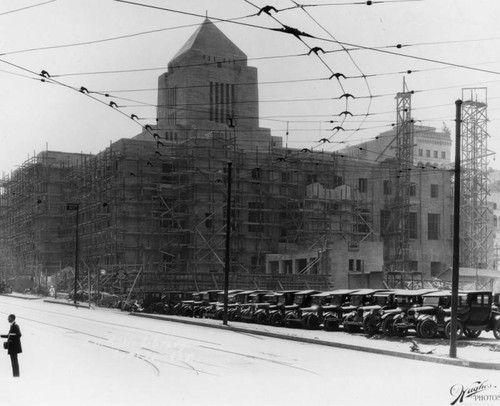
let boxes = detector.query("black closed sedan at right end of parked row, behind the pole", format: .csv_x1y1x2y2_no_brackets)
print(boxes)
435,290,500,340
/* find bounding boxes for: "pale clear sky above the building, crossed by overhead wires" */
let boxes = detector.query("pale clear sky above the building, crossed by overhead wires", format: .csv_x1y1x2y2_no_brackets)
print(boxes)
0,0,500,176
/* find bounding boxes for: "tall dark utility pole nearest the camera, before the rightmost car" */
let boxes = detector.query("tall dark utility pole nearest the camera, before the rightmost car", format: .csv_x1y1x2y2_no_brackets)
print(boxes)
450,100,462,358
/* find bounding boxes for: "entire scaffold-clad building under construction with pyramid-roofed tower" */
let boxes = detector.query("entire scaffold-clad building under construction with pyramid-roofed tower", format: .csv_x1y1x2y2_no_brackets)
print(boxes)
0,20,458,293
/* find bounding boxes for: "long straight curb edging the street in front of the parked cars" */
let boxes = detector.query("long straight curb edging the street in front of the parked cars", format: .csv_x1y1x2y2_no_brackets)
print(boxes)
129,313,500,370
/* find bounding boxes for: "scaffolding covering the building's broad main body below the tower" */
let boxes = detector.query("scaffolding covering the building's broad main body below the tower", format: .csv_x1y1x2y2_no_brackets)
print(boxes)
0,127,373,295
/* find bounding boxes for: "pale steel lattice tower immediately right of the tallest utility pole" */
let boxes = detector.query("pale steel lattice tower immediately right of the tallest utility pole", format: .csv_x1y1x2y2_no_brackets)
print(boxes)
460,88,489,268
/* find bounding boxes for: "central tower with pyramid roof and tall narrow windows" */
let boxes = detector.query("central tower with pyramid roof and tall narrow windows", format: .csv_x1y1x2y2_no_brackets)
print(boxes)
157,19,271,148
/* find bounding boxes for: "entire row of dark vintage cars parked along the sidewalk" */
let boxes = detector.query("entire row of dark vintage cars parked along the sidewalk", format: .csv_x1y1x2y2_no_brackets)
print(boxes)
133,289,500,339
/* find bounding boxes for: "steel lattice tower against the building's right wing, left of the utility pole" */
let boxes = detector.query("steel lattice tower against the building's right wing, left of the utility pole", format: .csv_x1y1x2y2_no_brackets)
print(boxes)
390,82,414,280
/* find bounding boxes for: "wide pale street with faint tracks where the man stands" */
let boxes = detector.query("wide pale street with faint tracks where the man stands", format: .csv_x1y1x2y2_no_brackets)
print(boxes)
0,296,500,405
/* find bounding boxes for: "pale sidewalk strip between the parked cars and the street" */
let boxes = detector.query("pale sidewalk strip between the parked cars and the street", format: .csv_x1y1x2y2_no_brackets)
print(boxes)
4,293,500,370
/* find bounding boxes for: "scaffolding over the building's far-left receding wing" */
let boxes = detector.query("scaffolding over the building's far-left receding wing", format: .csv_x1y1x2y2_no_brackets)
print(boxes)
0,151,92,290
